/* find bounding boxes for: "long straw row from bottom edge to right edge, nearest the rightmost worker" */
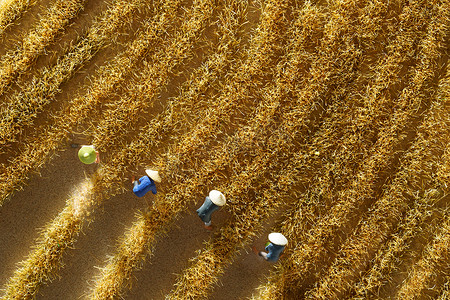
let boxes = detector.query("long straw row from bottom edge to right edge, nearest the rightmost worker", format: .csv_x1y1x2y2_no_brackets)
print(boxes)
307,66,450,299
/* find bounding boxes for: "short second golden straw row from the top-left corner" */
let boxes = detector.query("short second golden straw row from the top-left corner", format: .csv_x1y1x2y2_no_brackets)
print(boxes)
0,0,86,95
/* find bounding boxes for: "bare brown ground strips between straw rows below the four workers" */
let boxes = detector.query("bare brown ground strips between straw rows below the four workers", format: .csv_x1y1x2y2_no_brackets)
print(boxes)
0,146,271,300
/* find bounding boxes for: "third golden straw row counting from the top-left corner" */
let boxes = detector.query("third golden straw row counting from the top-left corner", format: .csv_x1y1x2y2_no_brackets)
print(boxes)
0,0,145,145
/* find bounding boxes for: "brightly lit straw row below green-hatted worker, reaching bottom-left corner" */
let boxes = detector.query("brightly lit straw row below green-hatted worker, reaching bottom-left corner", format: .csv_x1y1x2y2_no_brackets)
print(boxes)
0,0,237,297
